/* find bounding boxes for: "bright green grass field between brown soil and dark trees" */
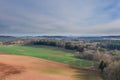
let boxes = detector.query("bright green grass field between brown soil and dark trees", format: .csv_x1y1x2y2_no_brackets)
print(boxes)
0,46,93,68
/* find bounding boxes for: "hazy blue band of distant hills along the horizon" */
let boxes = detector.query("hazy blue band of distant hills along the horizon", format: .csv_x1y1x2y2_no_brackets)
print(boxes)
0,36,120,41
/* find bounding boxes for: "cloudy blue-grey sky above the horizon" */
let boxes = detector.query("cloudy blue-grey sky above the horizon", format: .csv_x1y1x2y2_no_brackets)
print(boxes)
0,0,120,36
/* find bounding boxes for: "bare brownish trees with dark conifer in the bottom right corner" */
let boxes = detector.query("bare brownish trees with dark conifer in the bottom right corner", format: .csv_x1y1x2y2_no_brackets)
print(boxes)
98,51,120,80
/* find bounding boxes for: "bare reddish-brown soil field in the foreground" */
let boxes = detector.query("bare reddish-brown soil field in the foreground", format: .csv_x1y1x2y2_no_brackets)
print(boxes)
0,54,101,80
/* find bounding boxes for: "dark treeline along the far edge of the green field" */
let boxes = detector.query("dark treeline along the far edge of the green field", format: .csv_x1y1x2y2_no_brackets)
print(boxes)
34,39,84,52
